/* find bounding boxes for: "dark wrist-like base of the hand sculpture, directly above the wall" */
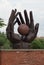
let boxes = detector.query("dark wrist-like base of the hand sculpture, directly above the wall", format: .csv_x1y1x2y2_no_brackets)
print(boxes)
12,42,31,49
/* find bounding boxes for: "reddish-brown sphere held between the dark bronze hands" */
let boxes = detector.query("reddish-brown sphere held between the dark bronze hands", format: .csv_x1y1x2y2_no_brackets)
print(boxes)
18,24,29,35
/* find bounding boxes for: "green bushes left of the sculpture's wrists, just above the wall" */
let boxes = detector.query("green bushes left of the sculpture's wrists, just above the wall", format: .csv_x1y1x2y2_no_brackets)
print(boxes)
0,33,12,49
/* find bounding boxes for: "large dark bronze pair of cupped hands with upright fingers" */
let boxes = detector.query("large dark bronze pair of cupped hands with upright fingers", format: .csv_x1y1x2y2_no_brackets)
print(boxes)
6,9,39,49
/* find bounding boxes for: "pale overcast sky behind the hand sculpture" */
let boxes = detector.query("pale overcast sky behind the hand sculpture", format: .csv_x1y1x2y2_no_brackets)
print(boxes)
0,0,44,36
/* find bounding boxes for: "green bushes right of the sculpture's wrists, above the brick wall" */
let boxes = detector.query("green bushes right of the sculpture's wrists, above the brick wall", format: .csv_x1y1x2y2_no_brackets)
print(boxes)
31,38,44,49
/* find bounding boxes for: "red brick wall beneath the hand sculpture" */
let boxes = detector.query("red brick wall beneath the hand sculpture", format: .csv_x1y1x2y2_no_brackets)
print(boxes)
0,51,44,65
